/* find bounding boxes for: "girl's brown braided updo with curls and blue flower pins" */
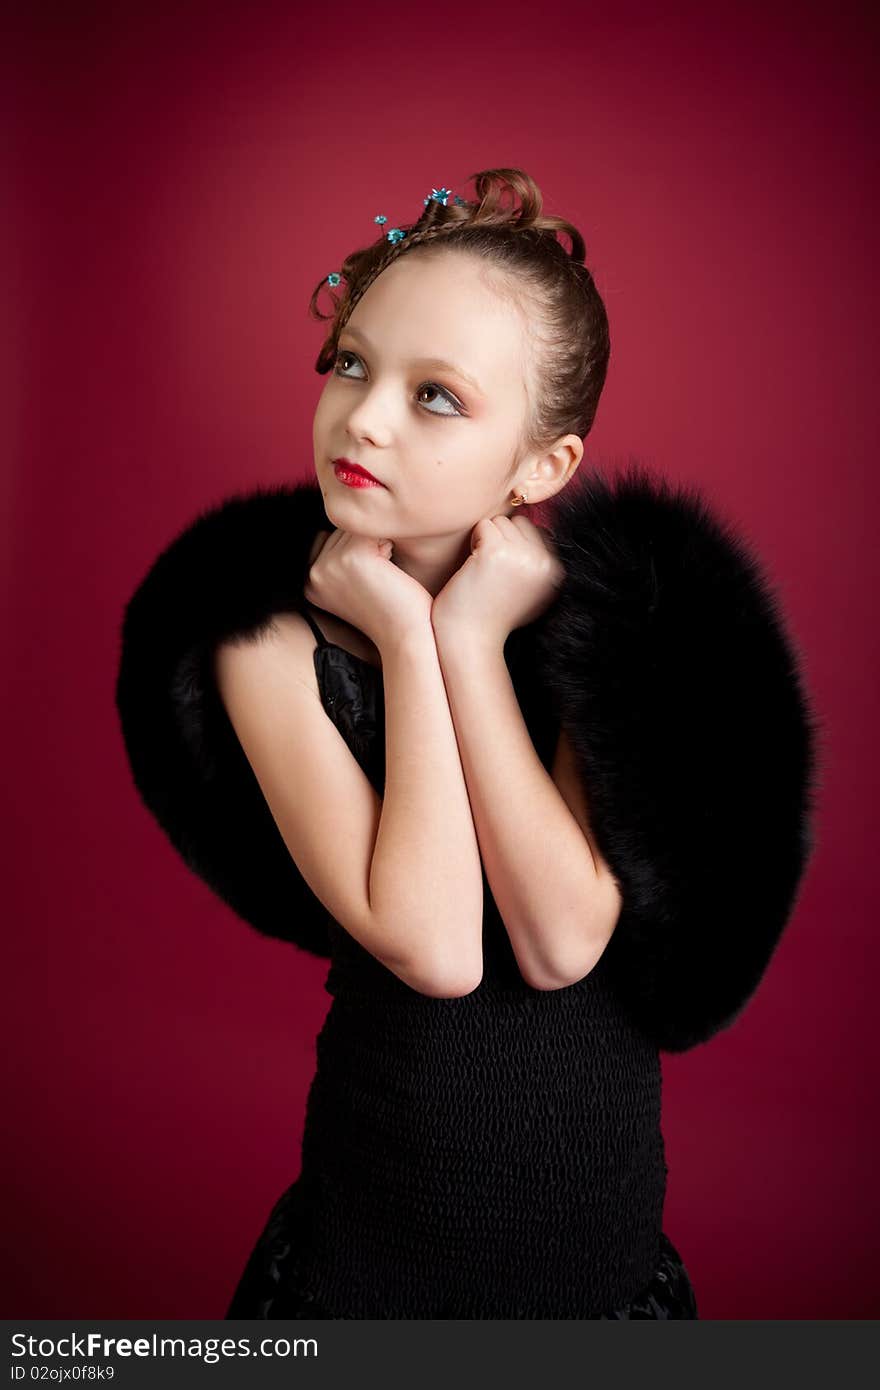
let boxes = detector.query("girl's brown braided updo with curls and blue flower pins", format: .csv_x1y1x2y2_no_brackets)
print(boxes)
309,168,610,467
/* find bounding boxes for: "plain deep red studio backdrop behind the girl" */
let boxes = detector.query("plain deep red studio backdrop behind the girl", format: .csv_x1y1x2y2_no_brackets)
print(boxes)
0,0,880,1319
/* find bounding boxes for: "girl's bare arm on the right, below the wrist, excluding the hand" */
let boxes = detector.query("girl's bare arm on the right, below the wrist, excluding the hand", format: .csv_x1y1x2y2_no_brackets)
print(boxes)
437,626,620,990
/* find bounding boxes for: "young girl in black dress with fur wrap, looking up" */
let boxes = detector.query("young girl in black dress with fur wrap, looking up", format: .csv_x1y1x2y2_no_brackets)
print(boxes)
117,170,817,1319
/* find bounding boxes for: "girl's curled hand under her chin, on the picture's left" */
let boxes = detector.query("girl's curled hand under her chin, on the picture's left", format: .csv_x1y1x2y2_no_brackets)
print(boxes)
303,528,431,651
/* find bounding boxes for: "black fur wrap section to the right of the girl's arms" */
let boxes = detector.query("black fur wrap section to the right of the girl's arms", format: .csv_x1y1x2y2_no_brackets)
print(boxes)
538,464,819,1052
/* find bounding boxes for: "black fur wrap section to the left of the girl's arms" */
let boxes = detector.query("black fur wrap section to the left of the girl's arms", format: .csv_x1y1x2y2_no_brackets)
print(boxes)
115,484,329,956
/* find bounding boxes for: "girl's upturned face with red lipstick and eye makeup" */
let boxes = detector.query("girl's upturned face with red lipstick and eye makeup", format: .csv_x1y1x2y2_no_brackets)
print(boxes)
313,253,553,541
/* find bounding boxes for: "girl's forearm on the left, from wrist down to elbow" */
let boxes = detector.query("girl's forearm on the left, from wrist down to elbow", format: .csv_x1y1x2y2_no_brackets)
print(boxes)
370,623,482,994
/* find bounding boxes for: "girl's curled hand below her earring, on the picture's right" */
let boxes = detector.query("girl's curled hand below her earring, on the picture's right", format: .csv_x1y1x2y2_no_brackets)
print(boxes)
431,513,566,646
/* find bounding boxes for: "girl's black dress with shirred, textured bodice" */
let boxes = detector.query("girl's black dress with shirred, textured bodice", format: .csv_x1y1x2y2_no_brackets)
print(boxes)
225,610,698,1319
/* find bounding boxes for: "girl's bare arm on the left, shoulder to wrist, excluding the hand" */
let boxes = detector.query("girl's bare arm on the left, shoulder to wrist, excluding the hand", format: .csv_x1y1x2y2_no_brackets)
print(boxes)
214,614,482,998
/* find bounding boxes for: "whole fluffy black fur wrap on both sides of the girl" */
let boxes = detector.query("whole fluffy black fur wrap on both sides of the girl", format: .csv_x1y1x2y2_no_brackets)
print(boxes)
115,466,817,1051
